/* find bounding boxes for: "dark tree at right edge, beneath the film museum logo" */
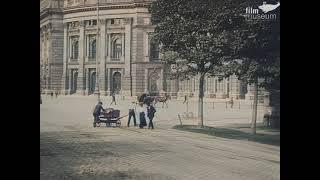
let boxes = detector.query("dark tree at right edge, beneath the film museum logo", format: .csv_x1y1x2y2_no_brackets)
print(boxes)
222,0,280,134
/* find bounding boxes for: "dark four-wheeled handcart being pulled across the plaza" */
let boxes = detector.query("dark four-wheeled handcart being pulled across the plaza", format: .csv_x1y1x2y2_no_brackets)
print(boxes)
97,109,127,127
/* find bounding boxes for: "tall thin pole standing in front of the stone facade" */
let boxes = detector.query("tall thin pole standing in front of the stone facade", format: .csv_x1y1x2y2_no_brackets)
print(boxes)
94,0,100,102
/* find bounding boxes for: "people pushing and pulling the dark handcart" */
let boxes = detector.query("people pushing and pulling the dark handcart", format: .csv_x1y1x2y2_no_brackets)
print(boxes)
93,94,156,129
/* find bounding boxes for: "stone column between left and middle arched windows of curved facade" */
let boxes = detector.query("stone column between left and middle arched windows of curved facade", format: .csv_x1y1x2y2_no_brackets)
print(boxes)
76,21,86,95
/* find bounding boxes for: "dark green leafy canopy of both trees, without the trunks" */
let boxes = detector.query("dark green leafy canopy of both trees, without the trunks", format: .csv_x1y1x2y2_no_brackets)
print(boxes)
150,0,280,87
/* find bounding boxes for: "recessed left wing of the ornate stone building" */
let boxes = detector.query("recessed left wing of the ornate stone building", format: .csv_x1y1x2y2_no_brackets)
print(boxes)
40,0,63,93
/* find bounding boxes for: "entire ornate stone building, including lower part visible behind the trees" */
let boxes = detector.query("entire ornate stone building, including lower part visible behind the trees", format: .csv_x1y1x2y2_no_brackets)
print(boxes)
40,0,264,99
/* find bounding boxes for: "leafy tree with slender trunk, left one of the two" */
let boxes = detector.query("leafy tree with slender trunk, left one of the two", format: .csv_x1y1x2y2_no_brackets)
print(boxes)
149,0,240,127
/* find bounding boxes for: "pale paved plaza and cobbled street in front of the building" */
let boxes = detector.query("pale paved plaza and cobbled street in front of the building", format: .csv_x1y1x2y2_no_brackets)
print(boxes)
40,96,280,180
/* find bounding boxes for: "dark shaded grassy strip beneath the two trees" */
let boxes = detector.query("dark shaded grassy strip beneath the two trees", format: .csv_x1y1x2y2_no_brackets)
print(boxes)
173,125,280,146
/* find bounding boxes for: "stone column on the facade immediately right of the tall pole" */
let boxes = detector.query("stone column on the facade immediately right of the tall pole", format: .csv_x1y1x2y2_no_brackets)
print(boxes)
96,19,106,96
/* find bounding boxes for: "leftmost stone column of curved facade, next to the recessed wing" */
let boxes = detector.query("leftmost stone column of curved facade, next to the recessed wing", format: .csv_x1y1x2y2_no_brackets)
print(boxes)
61,23,69,95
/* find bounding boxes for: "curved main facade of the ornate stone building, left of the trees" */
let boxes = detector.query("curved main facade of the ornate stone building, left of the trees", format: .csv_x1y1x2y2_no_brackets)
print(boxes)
62,0,164,96
